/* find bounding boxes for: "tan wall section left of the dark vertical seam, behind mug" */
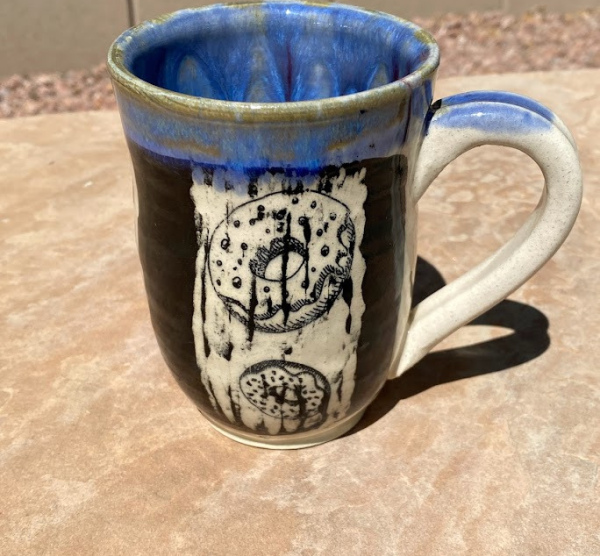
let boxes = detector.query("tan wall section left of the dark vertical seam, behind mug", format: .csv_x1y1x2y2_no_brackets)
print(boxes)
0,0,129,77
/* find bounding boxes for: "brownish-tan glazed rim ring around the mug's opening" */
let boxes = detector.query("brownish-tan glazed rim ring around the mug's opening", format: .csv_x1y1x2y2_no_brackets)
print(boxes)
108,0,440,123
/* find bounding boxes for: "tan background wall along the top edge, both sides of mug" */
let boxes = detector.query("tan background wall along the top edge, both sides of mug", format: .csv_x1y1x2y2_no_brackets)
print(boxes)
0,0,600,78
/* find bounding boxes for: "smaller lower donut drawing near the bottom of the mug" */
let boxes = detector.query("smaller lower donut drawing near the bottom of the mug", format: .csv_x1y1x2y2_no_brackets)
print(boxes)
240,360,331,428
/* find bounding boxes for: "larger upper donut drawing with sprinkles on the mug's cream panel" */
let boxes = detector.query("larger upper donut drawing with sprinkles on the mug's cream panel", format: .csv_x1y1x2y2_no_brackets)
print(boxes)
209,191,356,332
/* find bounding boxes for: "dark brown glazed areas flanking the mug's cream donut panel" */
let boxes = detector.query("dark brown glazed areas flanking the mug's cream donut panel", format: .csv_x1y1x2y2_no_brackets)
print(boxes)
129,141,407,432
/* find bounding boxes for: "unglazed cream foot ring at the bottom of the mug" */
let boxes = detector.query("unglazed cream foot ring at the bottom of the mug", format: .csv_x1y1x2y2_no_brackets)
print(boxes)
202,410,365,450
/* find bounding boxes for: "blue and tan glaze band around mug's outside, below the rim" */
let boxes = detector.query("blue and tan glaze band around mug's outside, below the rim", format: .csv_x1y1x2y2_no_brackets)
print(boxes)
117,95,412,169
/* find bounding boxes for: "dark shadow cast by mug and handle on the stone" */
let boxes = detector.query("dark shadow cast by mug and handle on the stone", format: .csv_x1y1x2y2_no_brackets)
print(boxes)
349,257,550,434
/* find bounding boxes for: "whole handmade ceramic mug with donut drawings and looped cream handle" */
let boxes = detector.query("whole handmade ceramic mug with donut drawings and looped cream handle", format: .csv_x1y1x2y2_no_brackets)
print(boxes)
108,2,581,448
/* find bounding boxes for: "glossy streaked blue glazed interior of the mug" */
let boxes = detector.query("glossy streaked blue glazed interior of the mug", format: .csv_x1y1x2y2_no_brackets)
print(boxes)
122,2,435,103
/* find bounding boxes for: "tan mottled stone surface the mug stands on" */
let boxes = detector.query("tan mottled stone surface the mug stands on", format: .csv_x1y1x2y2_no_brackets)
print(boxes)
0,70,600,556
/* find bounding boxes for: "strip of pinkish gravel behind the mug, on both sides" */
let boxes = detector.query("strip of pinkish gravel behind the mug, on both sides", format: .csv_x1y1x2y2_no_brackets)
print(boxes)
0,9,600,118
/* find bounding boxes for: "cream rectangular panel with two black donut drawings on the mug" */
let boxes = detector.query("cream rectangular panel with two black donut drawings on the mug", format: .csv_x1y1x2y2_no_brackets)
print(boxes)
190,165,367,435
